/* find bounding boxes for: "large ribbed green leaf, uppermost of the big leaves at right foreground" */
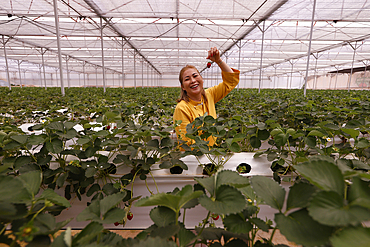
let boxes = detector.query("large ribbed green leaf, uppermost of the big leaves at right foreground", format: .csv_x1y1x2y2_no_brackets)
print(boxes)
295,156,344,195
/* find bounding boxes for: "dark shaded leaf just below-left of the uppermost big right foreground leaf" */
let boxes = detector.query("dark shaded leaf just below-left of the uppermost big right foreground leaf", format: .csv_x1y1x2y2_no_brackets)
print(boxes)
287,183,317,210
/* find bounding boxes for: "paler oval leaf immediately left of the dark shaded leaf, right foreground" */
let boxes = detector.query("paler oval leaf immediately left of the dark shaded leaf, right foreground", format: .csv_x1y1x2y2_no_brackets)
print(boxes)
250,176,286,211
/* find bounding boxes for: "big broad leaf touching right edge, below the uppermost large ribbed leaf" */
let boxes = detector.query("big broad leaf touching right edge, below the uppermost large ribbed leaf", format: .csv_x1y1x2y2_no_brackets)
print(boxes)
308,191,370,226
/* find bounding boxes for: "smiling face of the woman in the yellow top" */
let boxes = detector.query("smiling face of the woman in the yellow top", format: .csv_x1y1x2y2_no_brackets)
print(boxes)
181,68,203,101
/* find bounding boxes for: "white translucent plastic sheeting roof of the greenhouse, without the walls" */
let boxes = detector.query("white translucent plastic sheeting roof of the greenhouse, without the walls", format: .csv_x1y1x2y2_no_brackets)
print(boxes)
0,0,370,79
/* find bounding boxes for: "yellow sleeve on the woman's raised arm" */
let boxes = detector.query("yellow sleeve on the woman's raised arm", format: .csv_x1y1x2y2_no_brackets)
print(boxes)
207,69,240,103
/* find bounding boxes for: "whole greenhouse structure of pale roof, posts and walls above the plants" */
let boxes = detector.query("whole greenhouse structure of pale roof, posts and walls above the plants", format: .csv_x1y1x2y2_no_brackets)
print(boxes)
0,0,370,89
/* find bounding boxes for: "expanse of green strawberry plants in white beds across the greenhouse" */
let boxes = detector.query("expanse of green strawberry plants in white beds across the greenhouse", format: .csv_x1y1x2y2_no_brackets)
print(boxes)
0,88,370,246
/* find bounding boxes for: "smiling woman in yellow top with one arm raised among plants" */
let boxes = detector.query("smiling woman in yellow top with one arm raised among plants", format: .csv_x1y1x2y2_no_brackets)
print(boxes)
173,47,240,146
